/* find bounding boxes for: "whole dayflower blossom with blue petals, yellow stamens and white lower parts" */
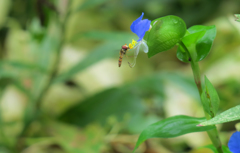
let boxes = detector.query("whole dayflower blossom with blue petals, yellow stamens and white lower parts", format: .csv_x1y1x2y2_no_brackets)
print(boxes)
129,13,151,67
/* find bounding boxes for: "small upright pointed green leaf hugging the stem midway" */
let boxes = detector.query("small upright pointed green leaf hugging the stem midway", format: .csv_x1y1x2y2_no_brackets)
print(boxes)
201,76,220,117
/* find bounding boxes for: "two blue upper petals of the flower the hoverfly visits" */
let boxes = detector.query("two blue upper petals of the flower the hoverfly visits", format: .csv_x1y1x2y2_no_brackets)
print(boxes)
130,12,151,42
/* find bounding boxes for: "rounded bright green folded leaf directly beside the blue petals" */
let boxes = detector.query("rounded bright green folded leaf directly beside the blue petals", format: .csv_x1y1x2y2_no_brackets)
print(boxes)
144,15,186,57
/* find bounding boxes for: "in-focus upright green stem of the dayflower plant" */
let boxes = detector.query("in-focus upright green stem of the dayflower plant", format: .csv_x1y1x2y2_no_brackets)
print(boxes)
179,42,223,153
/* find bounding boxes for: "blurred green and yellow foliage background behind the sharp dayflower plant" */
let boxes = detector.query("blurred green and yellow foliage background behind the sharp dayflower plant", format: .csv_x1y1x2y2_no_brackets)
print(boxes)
0,0,240,153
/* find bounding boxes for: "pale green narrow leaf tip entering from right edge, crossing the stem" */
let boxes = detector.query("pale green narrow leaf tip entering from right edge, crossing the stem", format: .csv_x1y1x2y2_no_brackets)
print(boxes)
200,105,240,126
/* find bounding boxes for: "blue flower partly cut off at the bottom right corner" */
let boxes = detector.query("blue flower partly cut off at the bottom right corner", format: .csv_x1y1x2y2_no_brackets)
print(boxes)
228,131,240,153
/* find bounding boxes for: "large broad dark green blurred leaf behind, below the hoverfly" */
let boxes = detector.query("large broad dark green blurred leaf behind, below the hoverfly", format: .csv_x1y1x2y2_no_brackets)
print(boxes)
60,75,165,132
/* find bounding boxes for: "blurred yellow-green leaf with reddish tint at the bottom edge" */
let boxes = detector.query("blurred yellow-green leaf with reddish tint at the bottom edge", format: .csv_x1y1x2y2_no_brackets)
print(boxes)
57,124,106,153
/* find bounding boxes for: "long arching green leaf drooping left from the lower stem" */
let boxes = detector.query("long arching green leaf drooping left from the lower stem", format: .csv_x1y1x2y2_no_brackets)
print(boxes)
133,115,215,152
